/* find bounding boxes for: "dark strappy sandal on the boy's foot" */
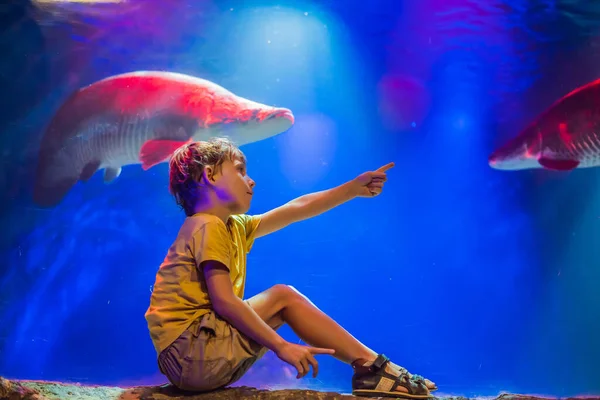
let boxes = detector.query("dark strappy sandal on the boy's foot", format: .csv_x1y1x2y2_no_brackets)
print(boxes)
352,354,433,399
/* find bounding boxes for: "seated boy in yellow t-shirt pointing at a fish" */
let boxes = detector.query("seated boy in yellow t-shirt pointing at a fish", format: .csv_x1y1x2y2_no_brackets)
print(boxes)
145,139,437,398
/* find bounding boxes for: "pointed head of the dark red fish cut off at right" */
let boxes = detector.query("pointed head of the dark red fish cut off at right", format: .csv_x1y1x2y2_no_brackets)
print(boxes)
488,128,542,171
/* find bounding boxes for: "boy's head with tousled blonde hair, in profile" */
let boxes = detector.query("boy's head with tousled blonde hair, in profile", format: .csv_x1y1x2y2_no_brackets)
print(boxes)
169,138,255,216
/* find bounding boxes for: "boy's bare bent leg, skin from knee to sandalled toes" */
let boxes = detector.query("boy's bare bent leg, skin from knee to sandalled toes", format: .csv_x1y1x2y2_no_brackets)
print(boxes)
248,285,435,389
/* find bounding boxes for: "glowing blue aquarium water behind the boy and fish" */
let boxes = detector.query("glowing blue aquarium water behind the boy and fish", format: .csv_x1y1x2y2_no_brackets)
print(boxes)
0,0,600,396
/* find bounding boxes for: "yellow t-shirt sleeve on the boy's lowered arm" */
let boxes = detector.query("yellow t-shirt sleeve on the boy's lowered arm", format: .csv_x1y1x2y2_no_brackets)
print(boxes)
191,221,231,269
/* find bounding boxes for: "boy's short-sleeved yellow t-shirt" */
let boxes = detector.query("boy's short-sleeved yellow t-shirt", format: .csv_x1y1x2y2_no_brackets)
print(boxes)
145,214,260,354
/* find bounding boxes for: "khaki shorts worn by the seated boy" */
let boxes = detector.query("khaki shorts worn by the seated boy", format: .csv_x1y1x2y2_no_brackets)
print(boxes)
158,311,267,391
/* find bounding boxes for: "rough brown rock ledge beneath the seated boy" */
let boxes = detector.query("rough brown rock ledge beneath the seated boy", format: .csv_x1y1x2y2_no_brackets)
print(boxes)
0,377,600,400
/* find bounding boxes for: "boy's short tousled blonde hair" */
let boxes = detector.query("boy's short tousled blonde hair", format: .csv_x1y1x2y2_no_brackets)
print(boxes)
169,138,246,216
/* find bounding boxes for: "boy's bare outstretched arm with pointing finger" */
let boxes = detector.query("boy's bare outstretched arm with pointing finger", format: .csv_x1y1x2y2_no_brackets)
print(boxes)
256,163,394,237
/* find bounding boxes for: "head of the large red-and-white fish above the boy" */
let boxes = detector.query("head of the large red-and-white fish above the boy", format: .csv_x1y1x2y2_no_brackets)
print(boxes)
198,96,294,145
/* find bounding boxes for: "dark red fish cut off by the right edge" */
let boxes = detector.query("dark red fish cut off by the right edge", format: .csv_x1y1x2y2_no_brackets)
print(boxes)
489,79,600,171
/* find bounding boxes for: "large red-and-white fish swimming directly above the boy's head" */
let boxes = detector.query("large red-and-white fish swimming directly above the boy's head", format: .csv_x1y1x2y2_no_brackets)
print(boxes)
33,71,294,207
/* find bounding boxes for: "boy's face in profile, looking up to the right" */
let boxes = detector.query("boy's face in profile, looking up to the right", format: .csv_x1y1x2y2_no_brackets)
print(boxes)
213,158,255,214
